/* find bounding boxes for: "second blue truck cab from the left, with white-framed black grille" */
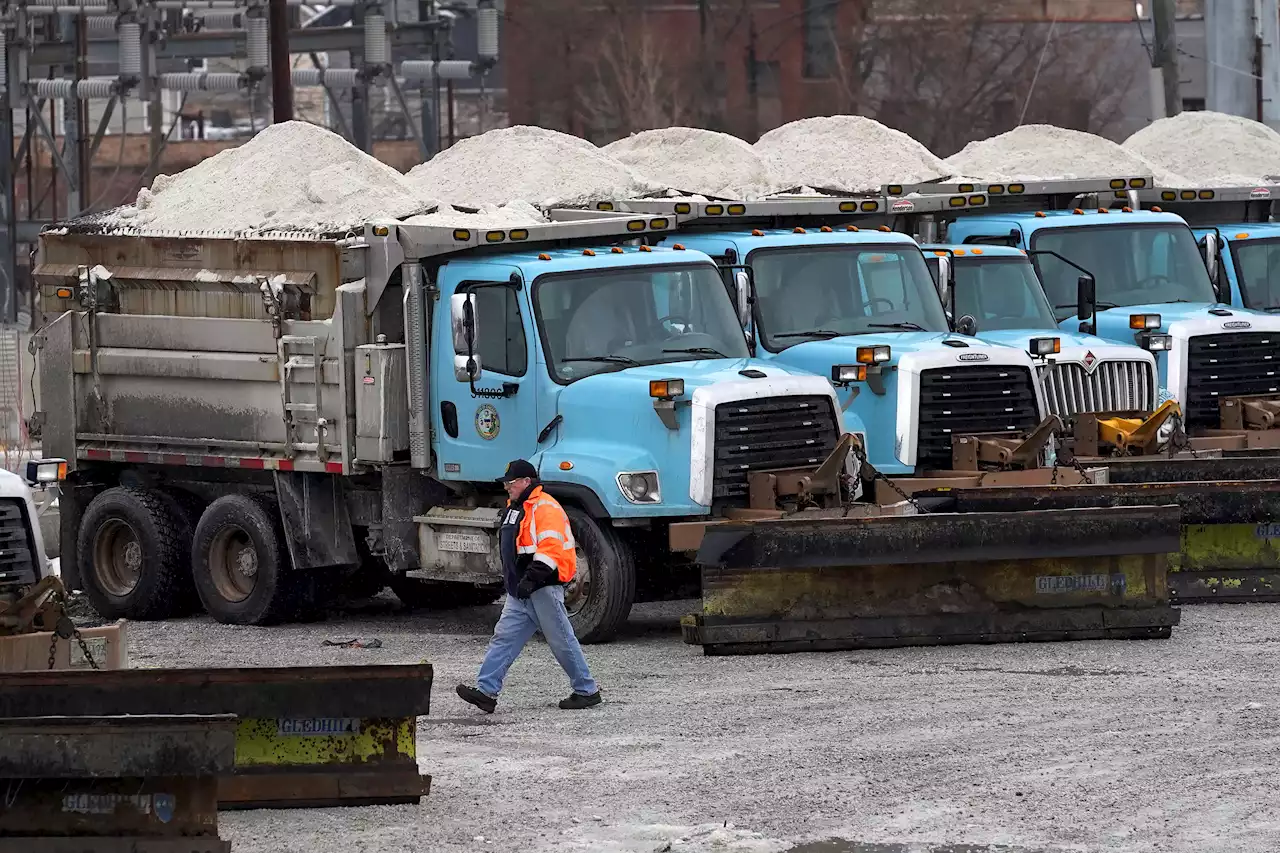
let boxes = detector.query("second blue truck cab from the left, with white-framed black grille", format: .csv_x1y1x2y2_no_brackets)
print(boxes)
622,200,1044,475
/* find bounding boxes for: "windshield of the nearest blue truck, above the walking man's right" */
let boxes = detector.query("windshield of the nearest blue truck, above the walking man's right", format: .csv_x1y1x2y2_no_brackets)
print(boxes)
534,264,749,383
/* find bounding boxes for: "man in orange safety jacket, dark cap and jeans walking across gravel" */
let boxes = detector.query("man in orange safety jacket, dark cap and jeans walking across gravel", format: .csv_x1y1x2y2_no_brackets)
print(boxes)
458,459,600,713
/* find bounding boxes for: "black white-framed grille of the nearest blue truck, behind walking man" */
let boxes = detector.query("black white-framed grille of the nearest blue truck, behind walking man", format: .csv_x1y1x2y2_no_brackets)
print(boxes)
712,397,840,506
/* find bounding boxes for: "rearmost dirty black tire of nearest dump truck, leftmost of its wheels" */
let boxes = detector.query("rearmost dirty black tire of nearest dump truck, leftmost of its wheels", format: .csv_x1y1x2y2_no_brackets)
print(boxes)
76,487,191,621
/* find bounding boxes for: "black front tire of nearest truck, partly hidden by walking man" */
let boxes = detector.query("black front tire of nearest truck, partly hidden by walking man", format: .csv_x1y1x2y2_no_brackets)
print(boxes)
564,506,636,643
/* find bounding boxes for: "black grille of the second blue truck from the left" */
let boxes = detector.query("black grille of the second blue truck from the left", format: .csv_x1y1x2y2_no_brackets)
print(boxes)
915,366,1041,470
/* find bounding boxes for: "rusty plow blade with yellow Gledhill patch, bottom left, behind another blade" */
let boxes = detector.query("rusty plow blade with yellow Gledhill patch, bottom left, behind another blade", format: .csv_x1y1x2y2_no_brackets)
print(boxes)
0,663,431,809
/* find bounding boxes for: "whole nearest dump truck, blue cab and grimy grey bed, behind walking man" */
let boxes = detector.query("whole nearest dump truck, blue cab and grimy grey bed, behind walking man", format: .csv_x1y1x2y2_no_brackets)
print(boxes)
36,214,849,640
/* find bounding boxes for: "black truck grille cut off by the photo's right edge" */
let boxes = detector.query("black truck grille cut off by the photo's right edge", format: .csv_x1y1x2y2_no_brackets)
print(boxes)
1187,332,1280,429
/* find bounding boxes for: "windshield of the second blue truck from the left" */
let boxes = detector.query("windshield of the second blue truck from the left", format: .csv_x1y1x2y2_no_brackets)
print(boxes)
749,245,947,352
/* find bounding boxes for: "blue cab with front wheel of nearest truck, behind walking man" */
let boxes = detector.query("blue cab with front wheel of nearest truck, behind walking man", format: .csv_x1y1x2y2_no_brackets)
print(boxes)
374,216,860,639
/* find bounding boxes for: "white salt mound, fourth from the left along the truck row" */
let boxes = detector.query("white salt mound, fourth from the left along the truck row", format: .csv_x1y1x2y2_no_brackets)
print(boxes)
755,115,951,192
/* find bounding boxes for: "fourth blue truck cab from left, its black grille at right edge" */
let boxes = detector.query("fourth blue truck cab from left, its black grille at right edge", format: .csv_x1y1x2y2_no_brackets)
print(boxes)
947,193,1280,435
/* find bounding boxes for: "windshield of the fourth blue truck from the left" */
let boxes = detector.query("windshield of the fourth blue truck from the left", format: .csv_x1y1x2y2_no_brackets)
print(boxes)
1032,224,1217,320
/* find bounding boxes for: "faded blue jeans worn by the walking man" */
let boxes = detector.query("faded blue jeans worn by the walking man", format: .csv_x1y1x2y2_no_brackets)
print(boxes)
476,584,599,697
